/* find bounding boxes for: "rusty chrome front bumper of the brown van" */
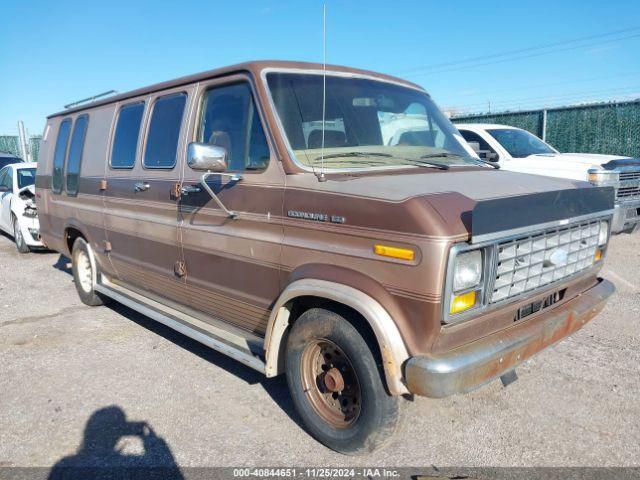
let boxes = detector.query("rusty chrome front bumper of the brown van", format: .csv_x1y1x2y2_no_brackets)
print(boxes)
405,279,615,398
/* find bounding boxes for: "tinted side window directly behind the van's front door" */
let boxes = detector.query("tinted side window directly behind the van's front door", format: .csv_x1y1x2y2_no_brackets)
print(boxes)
144,93,187,168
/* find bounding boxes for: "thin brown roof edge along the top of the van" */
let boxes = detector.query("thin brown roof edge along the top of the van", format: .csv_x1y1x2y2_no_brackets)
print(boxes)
47,60,423,118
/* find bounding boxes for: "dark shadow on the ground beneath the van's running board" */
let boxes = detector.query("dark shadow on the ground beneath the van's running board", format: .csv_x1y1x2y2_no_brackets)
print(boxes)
53,255,304,429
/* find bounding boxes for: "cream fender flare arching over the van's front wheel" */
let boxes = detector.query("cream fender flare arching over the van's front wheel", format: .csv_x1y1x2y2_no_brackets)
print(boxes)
264,278,409,395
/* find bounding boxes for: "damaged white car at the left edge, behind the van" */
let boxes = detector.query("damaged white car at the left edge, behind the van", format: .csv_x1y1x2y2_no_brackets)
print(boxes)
0,162,44,253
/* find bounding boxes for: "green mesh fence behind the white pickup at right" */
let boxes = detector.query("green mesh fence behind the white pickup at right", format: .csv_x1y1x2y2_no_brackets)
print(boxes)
452,100,640,157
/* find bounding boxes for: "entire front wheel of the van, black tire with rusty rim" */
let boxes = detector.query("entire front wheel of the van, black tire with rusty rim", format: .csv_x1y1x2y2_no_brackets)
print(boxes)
286,308,402,455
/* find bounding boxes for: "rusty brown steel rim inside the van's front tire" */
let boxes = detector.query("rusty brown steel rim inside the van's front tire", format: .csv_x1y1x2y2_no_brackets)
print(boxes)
300,339,362,428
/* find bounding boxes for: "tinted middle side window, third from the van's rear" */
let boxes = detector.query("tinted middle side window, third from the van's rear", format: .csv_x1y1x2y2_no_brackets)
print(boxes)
111,102,144,168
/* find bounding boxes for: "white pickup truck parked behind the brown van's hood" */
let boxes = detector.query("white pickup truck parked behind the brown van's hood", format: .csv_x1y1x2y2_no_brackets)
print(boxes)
456,123,640,233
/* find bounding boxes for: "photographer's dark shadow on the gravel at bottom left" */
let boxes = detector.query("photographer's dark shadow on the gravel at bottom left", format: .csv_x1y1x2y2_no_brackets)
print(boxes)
48,405,184,480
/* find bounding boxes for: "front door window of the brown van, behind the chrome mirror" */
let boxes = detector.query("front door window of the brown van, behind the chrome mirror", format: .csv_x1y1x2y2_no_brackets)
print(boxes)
198,83,270,171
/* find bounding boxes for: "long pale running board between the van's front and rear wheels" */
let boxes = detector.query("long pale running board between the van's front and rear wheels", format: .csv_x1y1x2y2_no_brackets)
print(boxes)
95,276,266,373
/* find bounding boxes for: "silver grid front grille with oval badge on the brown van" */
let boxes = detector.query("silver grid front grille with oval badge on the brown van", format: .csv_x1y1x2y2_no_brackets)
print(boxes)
489,220,600,303
